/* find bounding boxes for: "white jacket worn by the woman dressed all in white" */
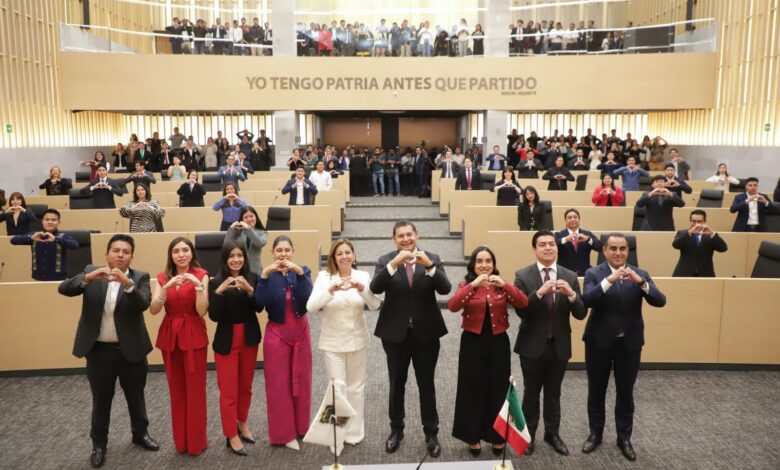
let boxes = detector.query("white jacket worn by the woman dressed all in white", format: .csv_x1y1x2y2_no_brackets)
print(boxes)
306,269,380,352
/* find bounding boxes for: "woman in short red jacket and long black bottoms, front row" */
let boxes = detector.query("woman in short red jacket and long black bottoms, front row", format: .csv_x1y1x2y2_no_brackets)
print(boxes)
447,246,528,456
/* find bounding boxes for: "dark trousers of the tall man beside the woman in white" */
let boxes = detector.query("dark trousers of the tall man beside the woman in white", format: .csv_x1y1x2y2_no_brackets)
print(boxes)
382,329,439,436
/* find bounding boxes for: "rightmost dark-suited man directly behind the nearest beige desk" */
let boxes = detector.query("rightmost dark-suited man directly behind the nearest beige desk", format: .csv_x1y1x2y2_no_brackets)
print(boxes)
672,209,728,277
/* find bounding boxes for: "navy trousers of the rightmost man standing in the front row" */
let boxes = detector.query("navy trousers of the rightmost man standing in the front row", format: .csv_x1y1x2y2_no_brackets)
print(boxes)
585,338,642,439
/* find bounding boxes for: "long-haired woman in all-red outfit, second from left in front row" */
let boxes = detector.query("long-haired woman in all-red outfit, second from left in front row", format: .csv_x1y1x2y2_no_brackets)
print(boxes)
149,237,209,455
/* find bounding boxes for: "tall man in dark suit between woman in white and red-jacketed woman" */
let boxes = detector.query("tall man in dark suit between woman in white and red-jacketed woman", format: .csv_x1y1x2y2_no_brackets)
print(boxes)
370,220,451,457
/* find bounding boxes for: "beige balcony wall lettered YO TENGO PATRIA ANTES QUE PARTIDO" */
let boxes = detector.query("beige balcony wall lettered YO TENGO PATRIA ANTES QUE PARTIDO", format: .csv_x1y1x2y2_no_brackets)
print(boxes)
61,52,717,111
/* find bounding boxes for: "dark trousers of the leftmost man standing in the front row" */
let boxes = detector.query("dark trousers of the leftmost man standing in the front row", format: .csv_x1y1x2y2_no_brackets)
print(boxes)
86,343,149,447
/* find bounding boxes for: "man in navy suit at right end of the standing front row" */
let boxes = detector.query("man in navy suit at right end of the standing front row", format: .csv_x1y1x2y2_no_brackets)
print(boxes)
582,233,666,461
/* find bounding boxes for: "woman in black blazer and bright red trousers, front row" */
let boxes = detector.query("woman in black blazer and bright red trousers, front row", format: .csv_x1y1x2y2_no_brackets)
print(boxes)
209,243,261,455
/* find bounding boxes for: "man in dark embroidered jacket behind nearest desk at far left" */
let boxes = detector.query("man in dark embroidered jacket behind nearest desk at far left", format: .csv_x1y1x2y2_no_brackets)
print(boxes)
11,209,79,281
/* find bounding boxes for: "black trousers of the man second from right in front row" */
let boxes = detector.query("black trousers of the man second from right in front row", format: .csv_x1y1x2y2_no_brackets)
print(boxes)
520,339,569,437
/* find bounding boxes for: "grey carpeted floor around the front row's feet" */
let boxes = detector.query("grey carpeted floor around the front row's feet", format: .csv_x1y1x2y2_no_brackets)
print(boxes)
0,306,780,470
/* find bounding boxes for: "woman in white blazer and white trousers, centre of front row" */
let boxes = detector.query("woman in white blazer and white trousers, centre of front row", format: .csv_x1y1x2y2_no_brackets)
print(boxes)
306,238,379,445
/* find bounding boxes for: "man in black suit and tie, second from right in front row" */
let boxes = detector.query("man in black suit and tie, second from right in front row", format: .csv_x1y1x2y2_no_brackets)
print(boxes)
515,230,587,455
